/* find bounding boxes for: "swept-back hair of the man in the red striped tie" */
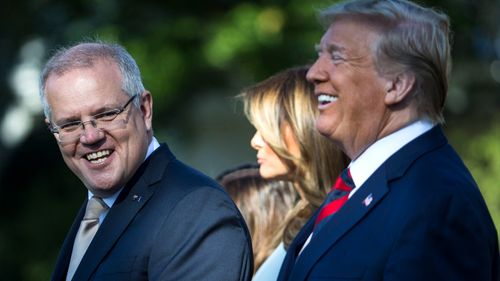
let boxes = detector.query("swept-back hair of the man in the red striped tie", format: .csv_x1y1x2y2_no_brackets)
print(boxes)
319,0,451,123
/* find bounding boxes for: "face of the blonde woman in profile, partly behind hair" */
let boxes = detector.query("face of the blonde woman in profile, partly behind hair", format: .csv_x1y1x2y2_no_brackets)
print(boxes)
250,125,300,179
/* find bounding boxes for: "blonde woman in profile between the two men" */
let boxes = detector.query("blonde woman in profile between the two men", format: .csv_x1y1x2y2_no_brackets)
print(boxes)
240,67,348,281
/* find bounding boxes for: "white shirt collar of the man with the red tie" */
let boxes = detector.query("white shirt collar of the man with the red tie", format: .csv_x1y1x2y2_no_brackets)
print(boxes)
349,120,434,197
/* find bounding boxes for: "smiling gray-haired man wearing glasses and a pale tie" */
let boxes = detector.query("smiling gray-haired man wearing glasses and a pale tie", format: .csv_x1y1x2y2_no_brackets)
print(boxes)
41,42,253,281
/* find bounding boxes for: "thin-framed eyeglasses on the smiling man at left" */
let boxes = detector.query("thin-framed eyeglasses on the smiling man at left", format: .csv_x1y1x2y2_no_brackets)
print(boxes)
48,95,139,143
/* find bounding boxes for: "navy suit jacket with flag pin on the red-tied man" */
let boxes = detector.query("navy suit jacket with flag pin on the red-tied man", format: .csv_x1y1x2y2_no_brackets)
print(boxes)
278,126,500,281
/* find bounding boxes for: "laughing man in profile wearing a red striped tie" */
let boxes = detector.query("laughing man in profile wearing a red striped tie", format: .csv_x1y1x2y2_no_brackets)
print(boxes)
278,0,500,281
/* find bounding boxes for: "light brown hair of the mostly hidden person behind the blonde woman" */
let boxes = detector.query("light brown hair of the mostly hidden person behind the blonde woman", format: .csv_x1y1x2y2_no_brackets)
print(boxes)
216,165,297,271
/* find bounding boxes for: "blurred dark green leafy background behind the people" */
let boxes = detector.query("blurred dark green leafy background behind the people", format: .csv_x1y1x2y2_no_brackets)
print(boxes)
0,0,500,281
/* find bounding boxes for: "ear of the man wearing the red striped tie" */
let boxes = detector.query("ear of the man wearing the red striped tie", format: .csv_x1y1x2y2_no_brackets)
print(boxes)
384,72,415,106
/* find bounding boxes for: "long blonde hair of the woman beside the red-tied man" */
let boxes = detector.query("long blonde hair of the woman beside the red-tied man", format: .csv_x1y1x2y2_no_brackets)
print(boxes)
240,67,348,247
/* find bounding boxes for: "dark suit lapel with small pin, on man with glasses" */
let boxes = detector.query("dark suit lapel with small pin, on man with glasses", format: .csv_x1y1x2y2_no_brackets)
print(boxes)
70,145,173,280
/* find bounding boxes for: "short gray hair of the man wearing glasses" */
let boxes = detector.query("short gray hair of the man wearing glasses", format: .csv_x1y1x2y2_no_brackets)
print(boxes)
40,41,145,119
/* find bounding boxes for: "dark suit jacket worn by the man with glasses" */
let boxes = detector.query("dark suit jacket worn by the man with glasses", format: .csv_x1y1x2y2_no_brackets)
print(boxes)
52,145,253,281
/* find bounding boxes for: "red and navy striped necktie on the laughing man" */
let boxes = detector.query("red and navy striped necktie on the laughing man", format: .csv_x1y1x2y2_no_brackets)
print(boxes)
314,168,354,230
